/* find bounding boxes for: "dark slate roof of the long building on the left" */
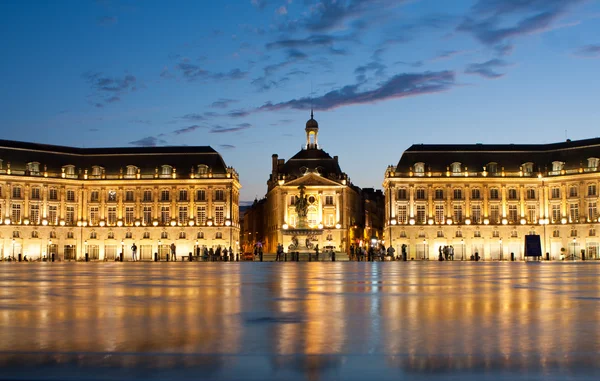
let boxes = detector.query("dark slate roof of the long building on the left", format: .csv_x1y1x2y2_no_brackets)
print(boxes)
0,140,227,175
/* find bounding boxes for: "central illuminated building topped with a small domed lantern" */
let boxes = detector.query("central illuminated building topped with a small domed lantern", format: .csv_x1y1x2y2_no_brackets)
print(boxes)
265,112,362,253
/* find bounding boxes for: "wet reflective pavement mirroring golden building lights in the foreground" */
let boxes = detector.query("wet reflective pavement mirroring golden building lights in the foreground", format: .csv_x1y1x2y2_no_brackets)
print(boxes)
0,262,600,381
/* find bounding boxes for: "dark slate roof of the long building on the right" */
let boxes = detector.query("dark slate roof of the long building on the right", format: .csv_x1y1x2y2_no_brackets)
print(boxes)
396,138,600,172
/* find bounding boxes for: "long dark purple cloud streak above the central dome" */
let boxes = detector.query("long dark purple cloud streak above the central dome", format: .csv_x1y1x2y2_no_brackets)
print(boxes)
257,70,455,111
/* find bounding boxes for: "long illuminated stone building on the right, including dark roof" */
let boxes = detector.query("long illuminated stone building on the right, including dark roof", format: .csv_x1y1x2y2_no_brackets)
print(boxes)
383,139,600,260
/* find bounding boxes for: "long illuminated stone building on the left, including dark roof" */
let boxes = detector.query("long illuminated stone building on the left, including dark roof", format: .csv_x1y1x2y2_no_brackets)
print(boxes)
0,141,240,260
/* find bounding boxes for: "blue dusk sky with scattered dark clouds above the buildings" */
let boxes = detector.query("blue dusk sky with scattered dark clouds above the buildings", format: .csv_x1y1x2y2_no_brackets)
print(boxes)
0,0,600,201
